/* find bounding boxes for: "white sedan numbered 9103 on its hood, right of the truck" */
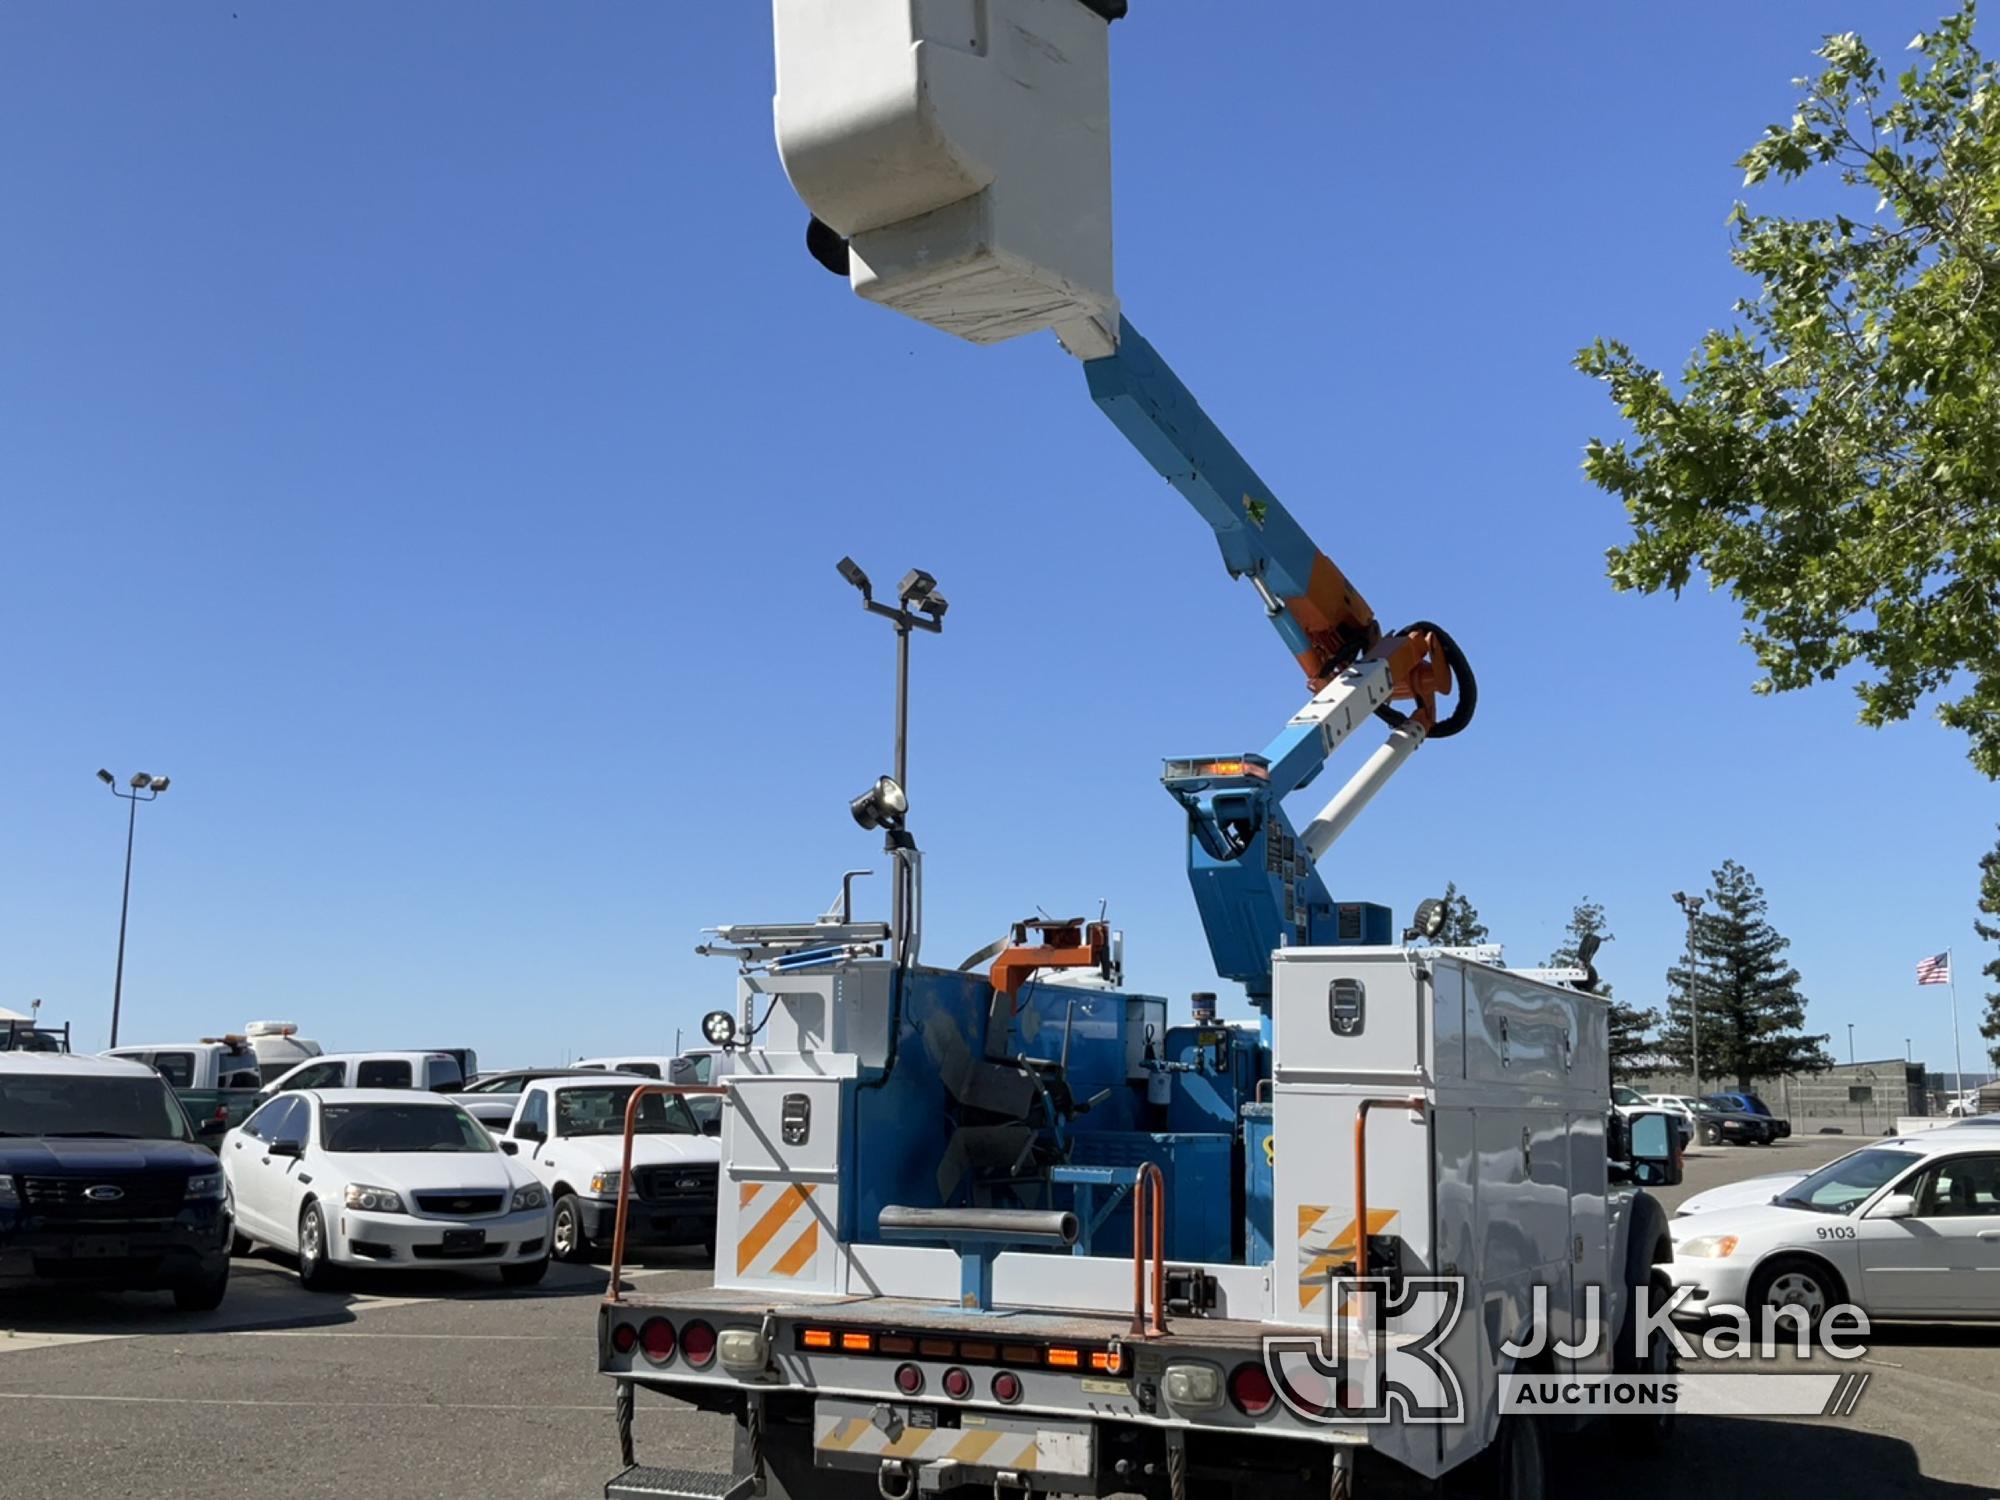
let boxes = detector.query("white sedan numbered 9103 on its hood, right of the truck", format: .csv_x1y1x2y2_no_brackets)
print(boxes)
1668,1128,2000,1320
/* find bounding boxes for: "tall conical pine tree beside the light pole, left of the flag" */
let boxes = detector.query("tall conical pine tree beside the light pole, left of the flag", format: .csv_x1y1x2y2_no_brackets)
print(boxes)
1660,860,1834,1088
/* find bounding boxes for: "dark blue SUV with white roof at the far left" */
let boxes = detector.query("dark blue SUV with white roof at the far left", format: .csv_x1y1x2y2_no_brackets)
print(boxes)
0,1052,230,1310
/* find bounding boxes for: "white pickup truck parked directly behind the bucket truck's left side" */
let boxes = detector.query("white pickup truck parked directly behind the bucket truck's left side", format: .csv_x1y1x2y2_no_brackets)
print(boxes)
500,1074,722,1260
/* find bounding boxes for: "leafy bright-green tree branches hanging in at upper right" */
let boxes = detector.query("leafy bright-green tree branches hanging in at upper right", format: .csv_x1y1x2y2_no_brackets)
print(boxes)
1576,4,2000,776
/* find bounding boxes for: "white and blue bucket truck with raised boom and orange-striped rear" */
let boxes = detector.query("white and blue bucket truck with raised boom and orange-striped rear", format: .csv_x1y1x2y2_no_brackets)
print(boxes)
598,0,1680,1500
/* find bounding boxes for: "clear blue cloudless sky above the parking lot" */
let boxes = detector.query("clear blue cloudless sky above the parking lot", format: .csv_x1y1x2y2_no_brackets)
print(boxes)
0,0,2000,1066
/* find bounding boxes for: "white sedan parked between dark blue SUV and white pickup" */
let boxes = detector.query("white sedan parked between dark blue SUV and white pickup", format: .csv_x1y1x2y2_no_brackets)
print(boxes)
220,1088,550,1288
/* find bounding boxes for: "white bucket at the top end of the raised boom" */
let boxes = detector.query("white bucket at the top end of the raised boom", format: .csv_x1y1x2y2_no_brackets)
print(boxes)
772,0,1118,360
